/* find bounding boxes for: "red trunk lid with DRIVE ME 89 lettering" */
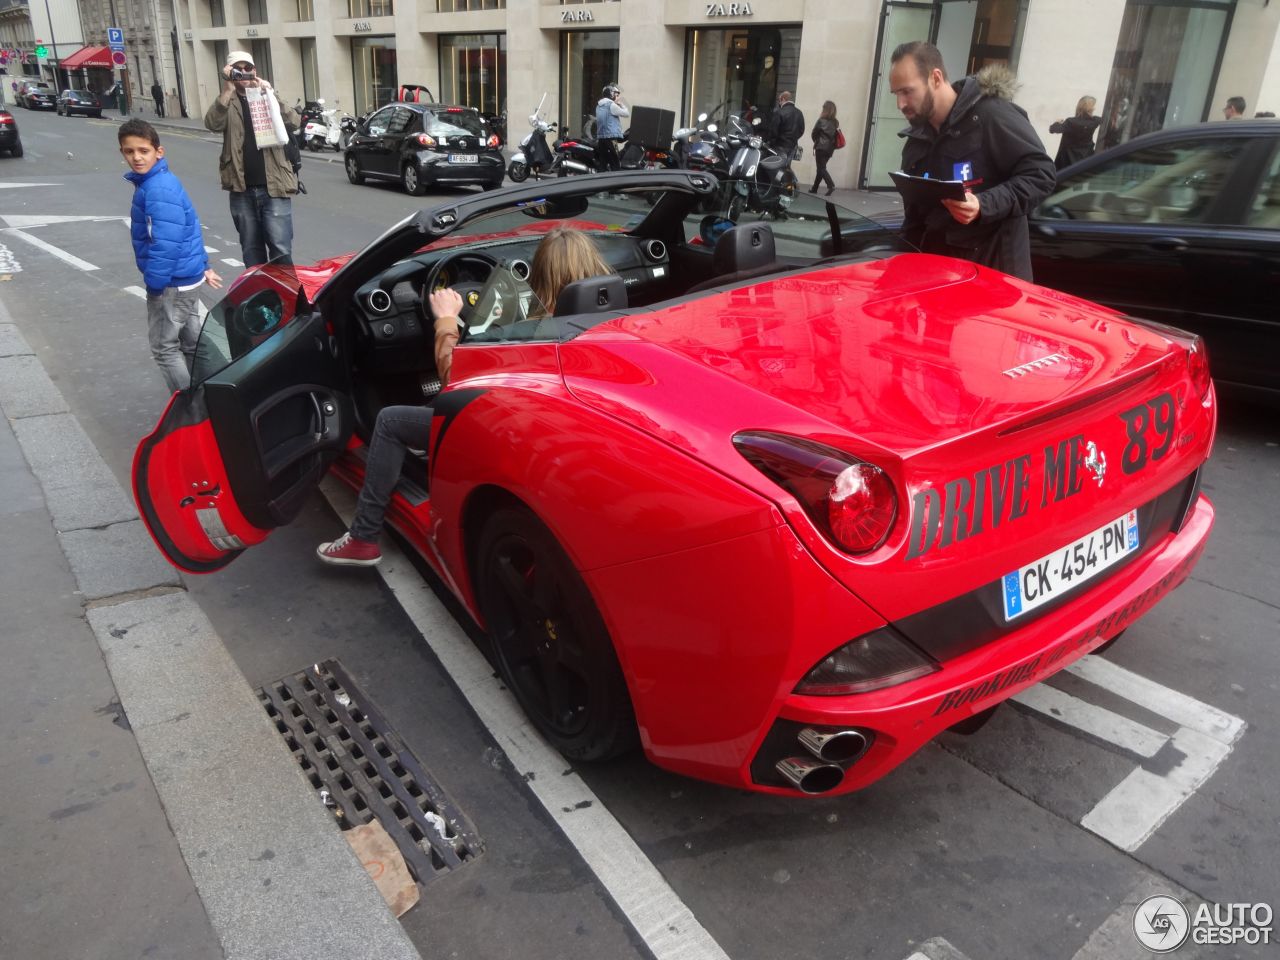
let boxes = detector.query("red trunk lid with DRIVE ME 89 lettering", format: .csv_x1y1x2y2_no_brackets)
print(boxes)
561,255,1213,640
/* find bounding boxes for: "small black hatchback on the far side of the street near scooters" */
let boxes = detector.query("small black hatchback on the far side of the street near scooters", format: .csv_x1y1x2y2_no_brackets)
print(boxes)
346,102,506,196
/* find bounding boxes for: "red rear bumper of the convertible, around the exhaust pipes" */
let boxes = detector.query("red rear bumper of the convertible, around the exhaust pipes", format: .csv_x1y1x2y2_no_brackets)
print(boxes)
584,497,1213,796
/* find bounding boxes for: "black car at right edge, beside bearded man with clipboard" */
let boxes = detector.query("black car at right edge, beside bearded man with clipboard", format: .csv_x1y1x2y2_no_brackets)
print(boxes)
1030,120,1280,401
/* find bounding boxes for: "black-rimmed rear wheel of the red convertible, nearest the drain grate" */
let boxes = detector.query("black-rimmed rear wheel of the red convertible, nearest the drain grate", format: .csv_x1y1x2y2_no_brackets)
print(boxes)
475,507,637,760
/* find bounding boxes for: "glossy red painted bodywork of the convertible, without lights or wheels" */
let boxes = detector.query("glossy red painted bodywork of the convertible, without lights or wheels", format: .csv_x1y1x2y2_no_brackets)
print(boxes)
134,220,1216,795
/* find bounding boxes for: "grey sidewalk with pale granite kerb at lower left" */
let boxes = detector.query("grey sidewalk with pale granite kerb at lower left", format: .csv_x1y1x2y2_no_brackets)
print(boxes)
0,295,420,960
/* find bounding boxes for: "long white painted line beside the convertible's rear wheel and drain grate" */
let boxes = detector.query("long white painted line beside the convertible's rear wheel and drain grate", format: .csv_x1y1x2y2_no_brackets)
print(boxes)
321,477,728,960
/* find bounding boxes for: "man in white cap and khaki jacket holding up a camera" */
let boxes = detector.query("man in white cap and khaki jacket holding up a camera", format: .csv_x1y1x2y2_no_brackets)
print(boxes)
205,50,298,266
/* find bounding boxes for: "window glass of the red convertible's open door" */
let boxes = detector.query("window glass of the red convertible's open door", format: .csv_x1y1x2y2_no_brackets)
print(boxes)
191,262,303,387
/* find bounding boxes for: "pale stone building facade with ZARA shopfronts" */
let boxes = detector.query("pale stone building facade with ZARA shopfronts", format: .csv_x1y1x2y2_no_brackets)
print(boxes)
175,0,1280,188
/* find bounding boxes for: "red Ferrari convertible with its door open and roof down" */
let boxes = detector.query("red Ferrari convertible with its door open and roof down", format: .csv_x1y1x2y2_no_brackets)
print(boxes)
134,172,1216,795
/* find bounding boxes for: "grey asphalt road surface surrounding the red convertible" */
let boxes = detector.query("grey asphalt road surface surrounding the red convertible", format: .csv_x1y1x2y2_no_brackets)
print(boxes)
0,110,1280,960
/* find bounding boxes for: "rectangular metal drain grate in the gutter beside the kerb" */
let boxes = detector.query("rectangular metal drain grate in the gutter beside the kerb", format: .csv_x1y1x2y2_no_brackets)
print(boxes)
257,660,484,884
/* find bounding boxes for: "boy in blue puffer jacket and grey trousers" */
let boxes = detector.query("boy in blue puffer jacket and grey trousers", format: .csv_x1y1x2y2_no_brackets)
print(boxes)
118,119,223,392
